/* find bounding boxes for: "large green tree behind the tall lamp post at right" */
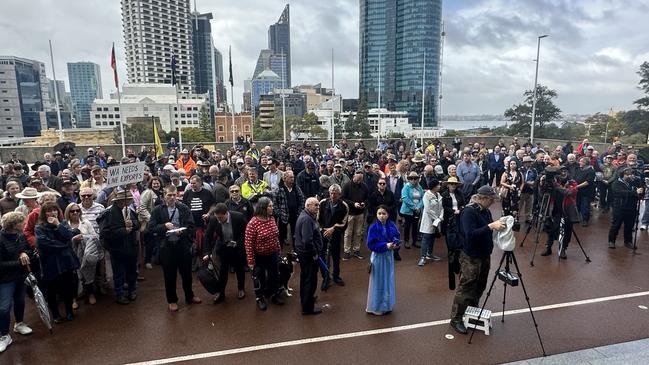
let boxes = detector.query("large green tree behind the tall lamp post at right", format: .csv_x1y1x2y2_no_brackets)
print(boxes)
505,85,561,137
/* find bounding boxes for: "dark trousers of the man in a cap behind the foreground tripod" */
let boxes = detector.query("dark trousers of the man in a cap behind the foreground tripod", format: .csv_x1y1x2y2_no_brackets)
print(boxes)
451,252,491,321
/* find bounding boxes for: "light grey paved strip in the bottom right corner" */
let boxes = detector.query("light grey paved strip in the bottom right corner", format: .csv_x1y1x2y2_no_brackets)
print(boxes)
507,339,649,365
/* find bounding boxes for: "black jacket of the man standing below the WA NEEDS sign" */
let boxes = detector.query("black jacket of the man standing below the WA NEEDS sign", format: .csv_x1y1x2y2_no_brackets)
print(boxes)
100,204,140,256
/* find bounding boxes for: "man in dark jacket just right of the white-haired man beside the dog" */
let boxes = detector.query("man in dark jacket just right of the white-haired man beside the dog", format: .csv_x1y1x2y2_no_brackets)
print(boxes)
318,184,349,290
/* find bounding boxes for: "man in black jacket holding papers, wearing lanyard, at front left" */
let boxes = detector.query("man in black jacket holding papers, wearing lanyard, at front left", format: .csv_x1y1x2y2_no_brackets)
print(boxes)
149,185,201,312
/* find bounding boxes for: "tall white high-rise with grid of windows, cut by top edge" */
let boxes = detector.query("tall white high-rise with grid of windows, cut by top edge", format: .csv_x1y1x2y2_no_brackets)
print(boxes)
121,0,194,93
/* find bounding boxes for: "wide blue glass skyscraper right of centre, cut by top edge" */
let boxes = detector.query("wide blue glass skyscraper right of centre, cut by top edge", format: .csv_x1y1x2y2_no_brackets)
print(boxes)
359,0,442,127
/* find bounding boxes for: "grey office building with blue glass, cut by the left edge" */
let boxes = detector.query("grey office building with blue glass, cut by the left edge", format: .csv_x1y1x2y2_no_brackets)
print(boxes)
0,56,51,138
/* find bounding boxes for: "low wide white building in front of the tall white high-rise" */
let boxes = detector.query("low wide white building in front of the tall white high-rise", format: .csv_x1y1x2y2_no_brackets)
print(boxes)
90,84,208,132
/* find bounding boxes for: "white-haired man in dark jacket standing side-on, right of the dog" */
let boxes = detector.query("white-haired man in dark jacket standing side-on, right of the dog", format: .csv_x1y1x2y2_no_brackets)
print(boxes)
295,198,322,315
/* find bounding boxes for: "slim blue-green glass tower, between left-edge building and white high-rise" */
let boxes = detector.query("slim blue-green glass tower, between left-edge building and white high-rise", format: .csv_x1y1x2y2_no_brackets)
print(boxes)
67,62,102,128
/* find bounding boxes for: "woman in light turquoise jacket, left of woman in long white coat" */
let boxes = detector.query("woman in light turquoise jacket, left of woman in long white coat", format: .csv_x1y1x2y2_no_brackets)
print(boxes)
399,171,424,248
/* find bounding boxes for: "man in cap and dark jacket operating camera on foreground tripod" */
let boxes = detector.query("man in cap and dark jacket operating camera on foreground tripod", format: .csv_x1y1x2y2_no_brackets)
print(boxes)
451,185,505,334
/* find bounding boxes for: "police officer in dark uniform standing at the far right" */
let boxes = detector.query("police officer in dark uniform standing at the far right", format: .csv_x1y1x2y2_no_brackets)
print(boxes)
608,167,644,249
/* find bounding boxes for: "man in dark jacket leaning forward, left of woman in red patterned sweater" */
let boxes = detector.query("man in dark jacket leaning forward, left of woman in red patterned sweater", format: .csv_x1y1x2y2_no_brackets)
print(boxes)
203,203,247,303
